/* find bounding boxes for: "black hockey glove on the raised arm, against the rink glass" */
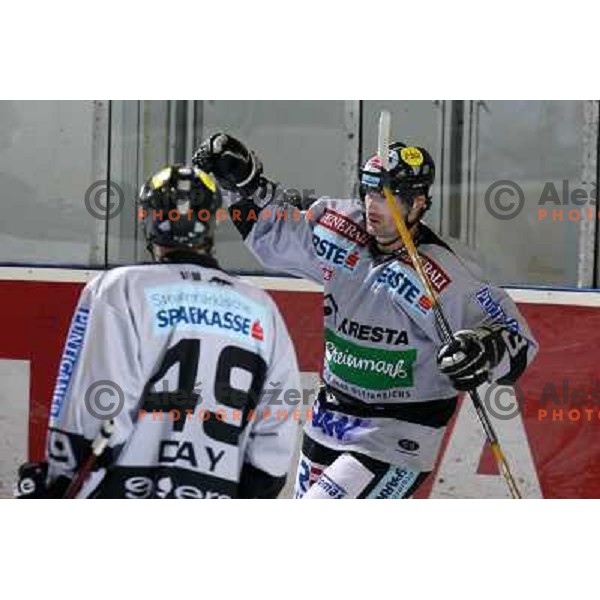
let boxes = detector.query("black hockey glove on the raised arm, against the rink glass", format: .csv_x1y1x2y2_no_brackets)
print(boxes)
192,133,263,197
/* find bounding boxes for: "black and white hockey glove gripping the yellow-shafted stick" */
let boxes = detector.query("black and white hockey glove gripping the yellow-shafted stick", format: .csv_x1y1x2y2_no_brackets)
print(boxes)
437,327,505,392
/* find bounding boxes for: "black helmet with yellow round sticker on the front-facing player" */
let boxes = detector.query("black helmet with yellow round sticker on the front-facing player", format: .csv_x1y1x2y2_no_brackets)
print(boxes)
360,142,435,208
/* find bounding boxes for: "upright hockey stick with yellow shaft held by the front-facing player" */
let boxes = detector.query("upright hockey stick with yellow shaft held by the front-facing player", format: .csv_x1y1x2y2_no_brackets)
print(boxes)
377,110,521,499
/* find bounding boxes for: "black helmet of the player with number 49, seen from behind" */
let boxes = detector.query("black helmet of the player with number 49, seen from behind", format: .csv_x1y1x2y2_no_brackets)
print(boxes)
137,164,221,251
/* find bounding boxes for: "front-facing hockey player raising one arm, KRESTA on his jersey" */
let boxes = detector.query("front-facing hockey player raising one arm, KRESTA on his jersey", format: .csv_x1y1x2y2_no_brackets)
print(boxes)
193,134,537,499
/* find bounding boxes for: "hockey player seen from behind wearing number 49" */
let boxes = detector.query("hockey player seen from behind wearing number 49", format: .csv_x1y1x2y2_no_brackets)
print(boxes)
17,165,300,498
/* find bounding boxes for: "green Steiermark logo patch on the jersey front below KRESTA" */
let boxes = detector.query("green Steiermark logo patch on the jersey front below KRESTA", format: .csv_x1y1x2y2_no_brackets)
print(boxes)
325,329,417,390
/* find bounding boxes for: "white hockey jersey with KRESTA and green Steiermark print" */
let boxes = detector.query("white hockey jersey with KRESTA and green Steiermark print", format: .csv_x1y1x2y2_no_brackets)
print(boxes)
230,198,537,471
